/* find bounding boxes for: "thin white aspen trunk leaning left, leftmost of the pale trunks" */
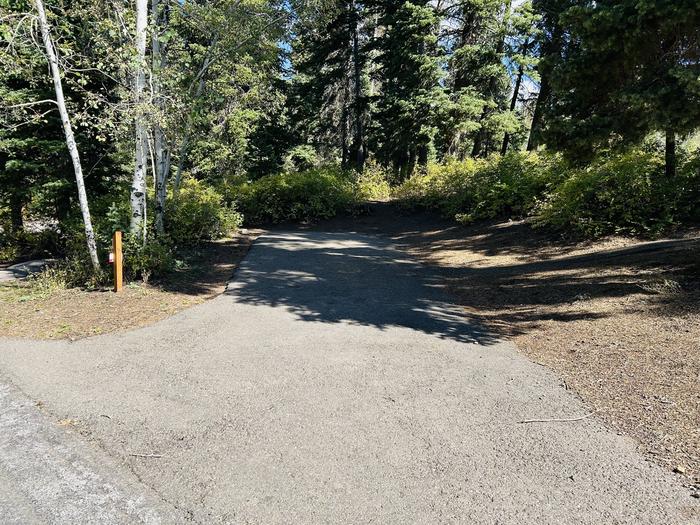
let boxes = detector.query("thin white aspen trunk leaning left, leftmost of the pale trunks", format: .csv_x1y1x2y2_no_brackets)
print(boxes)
34,0,100,273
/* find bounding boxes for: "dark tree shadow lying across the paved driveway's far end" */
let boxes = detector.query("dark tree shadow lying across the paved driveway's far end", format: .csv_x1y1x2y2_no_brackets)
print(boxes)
226,230,499,344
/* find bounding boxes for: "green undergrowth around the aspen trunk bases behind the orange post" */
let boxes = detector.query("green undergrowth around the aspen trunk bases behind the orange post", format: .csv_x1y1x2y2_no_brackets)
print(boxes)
0,178,243,291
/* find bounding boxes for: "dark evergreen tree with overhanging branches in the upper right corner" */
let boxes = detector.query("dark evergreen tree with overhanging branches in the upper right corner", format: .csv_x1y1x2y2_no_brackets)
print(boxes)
548,0,700,175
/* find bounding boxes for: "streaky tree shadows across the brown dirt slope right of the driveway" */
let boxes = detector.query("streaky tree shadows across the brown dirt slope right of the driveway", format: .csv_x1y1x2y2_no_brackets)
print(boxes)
294,203,700,336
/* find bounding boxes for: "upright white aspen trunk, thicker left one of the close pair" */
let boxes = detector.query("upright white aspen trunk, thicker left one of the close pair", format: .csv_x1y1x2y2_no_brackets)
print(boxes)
130,0,148,237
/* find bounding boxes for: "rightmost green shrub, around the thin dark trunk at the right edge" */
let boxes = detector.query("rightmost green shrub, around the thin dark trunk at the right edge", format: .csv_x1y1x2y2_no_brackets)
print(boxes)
537,151,700,236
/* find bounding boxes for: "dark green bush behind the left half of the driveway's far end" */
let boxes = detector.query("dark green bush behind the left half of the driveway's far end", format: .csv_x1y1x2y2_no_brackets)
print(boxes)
235,167,357,224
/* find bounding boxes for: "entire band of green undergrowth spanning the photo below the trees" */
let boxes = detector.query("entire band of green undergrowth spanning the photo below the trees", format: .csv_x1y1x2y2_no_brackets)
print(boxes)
0,149,700,290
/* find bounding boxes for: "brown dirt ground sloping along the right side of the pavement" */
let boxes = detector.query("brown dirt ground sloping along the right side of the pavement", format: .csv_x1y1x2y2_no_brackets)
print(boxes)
338,205,700,497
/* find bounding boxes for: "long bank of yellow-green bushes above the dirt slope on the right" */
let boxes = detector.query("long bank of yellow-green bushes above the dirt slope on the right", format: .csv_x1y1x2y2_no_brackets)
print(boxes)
395,150,700,237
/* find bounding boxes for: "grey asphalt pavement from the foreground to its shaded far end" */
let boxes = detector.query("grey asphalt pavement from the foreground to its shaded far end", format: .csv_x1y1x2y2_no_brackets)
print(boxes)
0,232,700,525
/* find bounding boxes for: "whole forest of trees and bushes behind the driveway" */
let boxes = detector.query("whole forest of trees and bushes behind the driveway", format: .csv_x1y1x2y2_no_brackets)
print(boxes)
0,0,700,286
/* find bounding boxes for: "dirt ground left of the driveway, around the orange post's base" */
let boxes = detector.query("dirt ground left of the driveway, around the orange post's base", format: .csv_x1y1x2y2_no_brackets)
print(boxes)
0,230,260,339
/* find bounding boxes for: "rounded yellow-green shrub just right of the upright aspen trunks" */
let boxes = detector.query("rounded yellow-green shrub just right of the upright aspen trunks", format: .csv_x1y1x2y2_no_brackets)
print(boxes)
165,178,243,246
